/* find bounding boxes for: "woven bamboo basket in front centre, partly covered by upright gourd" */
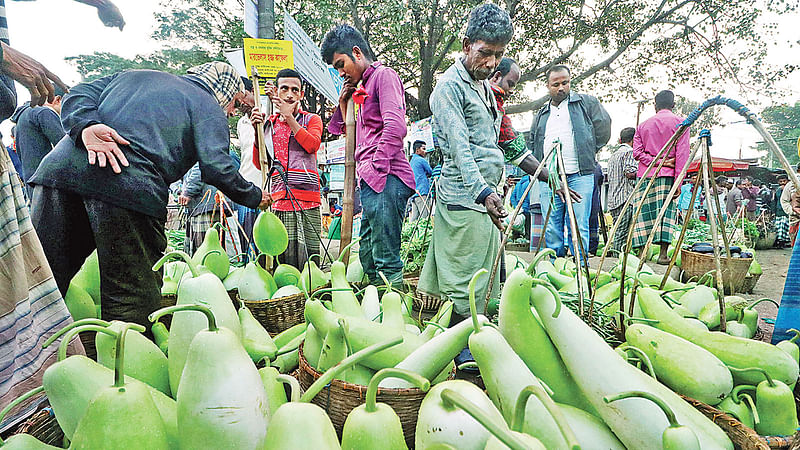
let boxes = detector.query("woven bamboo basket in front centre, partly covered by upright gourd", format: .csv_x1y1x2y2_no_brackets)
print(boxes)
297,344,453,448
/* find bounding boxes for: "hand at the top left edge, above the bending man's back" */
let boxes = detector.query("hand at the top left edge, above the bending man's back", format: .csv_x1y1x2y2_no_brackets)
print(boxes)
0,43,69,106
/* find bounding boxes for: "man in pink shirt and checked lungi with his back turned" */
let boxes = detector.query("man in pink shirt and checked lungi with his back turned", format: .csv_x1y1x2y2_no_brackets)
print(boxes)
632,91,689,264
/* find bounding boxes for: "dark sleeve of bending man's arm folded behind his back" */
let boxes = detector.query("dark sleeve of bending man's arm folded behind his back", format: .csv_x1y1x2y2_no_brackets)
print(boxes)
61,74,118,147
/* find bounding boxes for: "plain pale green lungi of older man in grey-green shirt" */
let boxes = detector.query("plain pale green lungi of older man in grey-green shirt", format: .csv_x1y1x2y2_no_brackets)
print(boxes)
417,201,500,316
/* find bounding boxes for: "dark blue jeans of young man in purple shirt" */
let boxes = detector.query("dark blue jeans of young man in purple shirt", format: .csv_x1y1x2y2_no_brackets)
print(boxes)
358,175,414,284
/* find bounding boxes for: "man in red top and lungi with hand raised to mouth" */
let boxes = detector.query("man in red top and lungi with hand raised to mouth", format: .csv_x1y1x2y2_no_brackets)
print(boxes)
252,69,322,269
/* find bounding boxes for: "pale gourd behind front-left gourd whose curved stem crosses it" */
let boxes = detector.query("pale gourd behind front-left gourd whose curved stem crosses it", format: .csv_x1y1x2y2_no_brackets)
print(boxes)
153,252,242,394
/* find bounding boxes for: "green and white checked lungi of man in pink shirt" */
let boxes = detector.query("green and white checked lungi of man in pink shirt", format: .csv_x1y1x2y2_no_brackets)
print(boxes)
632,177,677,248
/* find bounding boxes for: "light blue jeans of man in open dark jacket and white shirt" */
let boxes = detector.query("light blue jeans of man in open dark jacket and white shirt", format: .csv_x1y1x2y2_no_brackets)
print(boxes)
540,173,594,256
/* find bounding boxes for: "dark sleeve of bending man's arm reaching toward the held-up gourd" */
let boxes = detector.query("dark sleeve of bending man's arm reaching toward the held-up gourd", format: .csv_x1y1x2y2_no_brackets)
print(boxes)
193,116,261,208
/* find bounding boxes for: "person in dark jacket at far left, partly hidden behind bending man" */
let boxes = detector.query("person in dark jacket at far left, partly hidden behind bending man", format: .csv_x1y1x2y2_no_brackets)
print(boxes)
11,86,66,198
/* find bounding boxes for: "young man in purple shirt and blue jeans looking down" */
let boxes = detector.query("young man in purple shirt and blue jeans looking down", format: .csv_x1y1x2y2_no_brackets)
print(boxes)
321,25,415,285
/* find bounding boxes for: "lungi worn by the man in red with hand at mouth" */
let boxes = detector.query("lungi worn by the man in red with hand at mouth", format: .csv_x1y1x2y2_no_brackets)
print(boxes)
275,208,322,270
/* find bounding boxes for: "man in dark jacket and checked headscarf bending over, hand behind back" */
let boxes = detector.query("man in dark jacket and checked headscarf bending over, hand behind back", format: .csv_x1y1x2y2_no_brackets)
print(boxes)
30,62,269,324
